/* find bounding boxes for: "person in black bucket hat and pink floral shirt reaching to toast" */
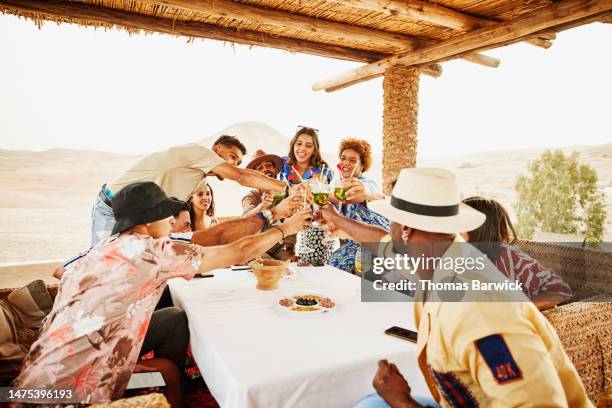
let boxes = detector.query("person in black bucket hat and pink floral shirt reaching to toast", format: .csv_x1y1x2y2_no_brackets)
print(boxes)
14,182,312,406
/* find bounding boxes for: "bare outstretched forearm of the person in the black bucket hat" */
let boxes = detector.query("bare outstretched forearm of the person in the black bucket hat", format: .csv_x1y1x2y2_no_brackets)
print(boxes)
200,210,312,272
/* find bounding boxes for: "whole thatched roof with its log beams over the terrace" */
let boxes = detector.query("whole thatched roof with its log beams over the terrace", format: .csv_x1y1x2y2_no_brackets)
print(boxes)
0,0,612,89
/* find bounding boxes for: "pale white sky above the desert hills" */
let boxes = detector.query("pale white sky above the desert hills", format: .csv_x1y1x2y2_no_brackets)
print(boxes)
0,15,612,157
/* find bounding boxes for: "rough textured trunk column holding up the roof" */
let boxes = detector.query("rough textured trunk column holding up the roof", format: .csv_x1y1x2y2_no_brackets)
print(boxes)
383,66,419,195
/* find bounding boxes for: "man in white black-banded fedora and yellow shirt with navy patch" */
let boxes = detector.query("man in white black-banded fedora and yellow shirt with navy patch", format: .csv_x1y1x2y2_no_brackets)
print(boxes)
320,168,593,408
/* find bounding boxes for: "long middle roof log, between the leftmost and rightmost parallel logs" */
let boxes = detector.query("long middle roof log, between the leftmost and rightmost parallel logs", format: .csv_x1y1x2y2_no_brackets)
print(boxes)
149,0,499,67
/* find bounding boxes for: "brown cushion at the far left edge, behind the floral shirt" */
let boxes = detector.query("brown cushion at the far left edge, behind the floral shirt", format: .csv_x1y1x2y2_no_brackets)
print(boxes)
0,280,53,386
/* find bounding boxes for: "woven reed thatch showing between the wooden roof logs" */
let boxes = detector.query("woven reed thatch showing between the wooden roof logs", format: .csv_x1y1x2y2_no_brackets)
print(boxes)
0,0,551,54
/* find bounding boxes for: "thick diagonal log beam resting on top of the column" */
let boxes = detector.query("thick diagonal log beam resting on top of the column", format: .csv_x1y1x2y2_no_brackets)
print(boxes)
312,0,612,91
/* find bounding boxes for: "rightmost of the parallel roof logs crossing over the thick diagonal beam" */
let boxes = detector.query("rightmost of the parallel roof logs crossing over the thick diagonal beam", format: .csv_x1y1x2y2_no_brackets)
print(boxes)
333,0,554,48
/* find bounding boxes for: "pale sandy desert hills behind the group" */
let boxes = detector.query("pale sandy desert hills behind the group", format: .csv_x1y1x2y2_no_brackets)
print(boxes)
0,124,612,287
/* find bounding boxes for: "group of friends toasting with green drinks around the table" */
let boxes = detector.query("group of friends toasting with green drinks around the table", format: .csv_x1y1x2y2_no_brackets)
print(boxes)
13,127,591,408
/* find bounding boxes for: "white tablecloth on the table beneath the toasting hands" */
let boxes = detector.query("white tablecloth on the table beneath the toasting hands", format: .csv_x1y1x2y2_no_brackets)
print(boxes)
169,266,429,408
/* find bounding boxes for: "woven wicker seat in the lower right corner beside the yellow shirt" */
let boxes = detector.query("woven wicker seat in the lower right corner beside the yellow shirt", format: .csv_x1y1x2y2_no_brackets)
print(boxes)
543,295,612,402
